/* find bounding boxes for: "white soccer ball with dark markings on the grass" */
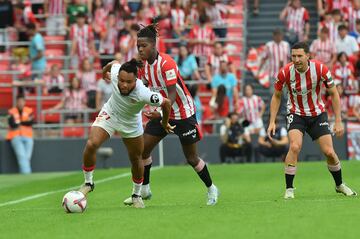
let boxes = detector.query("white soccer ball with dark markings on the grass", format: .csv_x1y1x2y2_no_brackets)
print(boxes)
62,191,87,213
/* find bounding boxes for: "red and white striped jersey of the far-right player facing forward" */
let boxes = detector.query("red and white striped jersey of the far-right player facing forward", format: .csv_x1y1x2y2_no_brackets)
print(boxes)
275,60,334,116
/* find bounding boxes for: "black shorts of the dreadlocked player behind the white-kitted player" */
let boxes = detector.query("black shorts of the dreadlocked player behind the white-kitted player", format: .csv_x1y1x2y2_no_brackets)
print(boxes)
144,114,202,144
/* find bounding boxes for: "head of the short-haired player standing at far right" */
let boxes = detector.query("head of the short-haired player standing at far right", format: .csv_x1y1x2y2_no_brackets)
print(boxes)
291,42,310,72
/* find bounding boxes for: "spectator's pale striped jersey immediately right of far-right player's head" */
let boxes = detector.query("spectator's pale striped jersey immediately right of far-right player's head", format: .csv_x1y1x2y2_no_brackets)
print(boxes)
310,39,336,63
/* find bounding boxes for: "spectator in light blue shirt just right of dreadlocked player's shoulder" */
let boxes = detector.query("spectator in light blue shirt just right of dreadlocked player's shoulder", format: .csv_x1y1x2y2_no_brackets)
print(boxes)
174,45,201,83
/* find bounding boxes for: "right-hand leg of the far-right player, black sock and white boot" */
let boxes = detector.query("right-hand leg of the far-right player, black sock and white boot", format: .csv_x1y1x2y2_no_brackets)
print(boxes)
317,134,356,196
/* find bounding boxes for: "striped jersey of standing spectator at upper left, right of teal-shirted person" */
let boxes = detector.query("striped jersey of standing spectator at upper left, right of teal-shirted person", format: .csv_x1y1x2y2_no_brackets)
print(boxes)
70,24,94,59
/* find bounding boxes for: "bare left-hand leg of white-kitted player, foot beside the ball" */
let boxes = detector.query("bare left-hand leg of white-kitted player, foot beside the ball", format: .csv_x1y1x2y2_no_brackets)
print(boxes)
79,126,110,195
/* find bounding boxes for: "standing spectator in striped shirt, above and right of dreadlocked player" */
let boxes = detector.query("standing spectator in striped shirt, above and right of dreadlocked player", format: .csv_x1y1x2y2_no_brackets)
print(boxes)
189,14,215,67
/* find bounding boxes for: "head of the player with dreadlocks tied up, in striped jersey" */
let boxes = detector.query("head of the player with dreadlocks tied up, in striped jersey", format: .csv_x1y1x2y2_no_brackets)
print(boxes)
137,23,158,61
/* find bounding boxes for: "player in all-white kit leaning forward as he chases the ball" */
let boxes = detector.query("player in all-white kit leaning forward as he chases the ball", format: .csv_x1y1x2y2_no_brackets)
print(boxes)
80,59,174,208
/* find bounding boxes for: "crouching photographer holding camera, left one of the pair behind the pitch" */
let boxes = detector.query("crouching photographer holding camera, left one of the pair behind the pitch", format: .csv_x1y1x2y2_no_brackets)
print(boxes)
219,112,252,163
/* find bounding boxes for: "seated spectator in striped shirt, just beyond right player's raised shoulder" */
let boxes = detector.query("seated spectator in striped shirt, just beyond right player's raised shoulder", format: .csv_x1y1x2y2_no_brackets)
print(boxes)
333,52,358,93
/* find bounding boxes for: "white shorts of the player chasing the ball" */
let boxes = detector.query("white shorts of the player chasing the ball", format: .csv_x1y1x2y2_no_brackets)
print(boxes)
92,107,144,138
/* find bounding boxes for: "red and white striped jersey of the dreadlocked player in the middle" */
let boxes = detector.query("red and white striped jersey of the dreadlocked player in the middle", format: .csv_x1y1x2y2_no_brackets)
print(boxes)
139,53,195,120
